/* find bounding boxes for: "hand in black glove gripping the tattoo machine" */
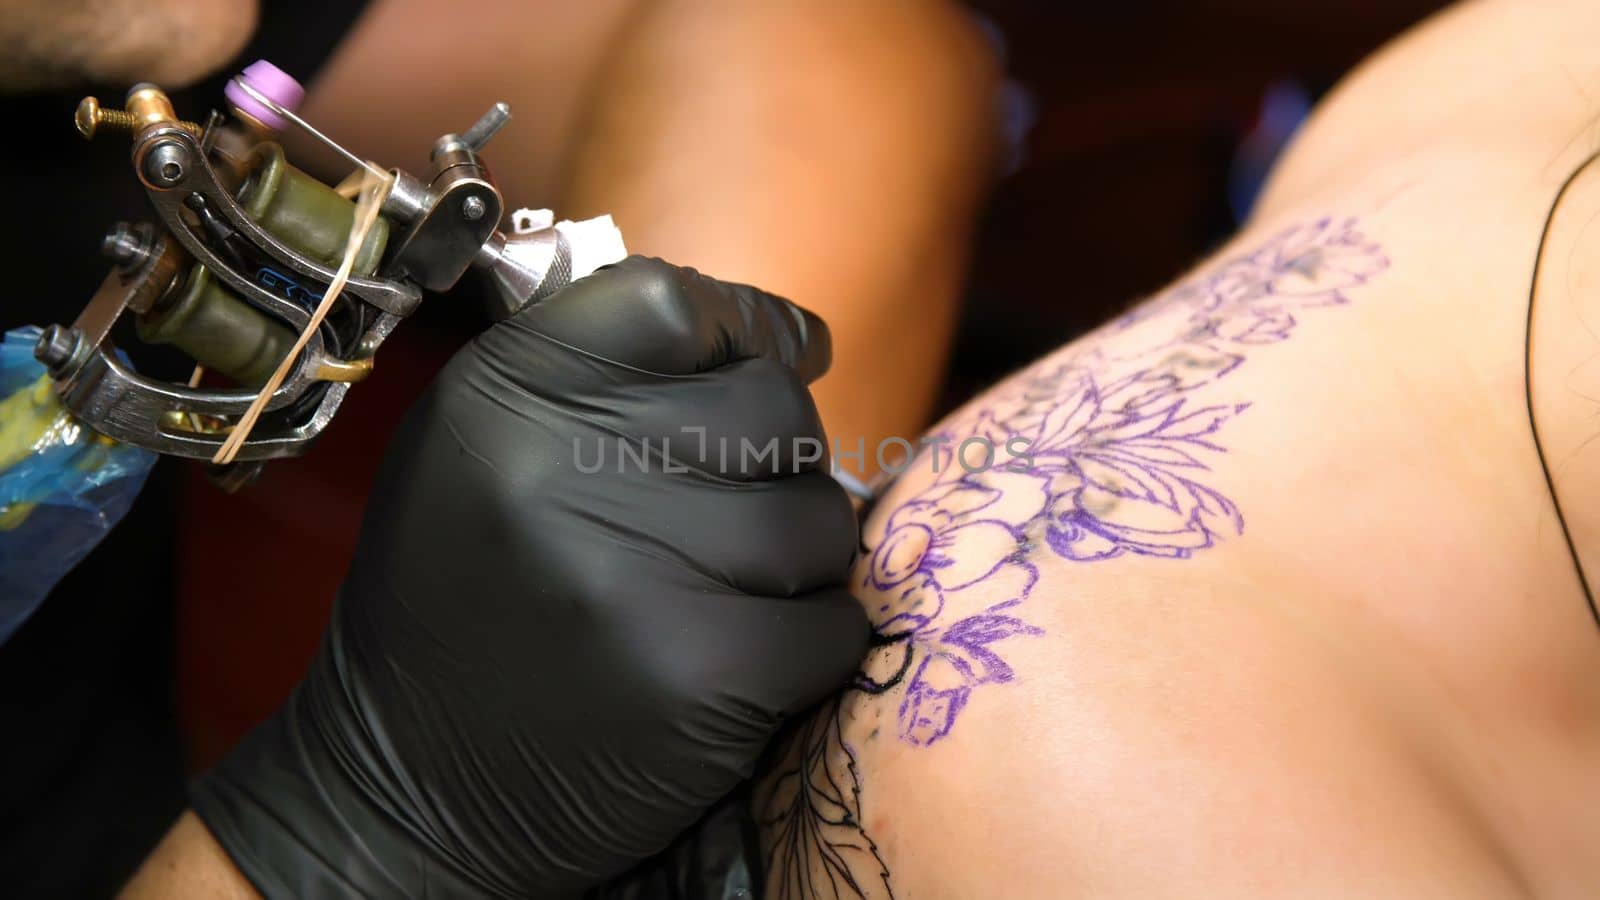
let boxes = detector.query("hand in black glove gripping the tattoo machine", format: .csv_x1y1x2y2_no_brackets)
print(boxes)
194,258,869,898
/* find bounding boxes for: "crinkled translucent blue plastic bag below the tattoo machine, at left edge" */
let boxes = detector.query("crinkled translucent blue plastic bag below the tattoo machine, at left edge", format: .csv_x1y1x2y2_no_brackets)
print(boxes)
0,327,155,644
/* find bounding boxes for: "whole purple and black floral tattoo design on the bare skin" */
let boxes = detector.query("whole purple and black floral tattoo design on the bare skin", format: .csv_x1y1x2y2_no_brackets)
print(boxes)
758,218,1389,898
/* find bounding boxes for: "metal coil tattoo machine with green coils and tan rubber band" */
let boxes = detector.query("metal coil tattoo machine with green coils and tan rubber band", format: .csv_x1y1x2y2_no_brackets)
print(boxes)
34,61,624,485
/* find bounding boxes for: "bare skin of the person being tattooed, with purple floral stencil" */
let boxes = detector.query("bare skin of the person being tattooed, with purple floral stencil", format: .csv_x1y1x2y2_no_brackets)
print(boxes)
755,2,1600,898
